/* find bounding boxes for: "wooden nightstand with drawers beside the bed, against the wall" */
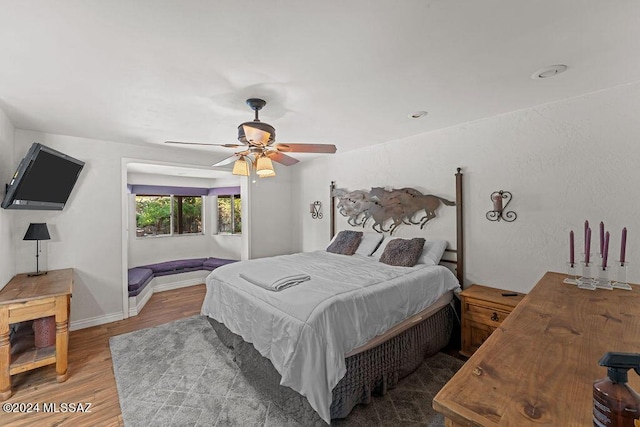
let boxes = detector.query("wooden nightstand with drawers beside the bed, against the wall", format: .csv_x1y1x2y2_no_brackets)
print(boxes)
460,285,525,357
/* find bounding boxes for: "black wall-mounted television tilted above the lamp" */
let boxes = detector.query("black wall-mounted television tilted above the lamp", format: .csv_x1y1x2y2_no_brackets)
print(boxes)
1,142,84,211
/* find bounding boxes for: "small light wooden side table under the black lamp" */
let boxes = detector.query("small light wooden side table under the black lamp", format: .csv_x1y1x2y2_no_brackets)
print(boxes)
0,268,73,401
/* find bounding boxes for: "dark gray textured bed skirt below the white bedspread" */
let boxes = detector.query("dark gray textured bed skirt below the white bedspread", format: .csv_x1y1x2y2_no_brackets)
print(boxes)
208,304,455,426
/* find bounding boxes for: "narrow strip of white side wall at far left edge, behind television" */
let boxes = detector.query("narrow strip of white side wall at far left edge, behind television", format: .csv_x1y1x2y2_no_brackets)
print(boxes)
0,110,15,289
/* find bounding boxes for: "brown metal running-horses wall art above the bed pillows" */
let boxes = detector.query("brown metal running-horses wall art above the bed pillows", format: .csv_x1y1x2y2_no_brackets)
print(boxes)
331,187,455,234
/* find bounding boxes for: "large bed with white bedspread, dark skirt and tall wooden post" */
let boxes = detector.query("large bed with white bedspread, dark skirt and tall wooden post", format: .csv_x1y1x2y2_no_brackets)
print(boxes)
202,170,462,424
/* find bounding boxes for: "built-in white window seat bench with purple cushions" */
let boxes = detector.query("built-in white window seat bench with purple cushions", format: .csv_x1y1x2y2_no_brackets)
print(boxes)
128,258,236,316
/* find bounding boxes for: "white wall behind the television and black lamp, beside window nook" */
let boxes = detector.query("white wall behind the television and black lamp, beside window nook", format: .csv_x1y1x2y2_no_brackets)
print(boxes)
10,130,245,325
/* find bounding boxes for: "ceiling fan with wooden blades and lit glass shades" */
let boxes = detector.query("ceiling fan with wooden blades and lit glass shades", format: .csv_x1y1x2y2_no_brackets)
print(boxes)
165,98,336,178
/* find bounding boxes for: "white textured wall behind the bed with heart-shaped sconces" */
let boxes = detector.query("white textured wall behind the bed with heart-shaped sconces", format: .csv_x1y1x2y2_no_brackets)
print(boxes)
292,80,640,292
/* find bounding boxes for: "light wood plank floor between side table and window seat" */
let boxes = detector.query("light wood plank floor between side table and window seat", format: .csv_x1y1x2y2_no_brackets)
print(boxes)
0,285,205,427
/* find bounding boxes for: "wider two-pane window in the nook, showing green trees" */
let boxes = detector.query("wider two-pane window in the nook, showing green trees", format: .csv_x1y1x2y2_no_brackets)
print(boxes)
136,195,203,237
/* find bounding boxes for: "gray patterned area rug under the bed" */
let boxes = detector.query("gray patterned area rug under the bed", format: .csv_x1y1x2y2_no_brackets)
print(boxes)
109,316,463,427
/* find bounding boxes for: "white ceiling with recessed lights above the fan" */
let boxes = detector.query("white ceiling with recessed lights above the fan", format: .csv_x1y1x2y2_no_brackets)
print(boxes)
0,0,640,170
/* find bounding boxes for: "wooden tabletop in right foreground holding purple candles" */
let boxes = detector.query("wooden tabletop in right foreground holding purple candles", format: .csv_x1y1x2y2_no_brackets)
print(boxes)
433,273,640,427
